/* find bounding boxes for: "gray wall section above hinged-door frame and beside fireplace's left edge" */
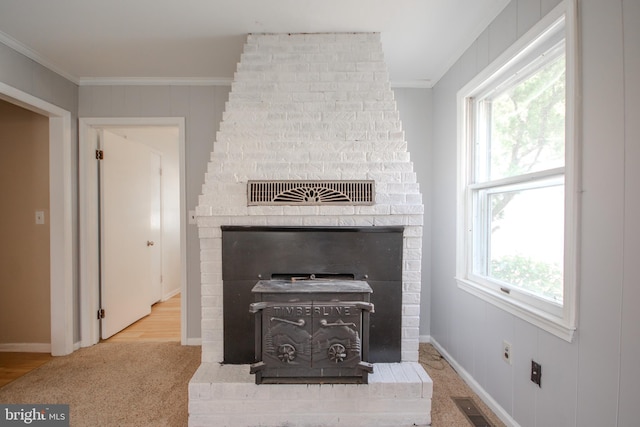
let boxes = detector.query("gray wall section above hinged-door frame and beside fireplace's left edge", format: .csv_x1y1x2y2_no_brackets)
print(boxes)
78,86,231,340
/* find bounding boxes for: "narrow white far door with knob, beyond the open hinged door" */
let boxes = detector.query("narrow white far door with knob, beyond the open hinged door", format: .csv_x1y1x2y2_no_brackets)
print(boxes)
149,151,164,304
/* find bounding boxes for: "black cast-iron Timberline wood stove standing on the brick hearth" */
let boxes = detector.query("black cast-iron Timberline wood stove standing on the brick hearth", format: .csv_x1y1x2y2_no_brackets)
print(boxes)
250,275,373,384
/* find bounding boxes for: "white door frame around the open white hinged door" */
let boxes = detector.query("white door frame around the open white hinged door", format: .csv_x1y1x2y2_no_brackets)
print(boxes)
78,117,188,347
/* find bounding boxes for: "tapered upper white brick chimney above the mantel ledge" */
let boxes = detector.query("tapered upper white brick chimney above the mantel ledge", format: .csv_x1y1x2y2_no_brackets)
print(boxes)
198,33,422,224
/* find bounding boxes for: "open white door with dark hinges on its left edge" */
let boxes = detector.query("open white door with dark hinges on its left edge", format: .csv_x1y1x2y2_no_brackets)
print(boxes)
100,131,153,339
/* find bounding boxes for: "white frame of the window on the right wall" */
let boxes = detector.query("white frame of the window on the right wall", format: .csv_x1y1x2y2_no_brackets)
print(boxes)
456,0,580,342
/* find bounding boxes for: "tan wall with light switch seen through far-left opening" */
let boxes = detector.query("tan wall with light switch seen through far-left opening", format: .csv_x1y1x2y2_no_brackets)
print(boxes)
0,100,51,353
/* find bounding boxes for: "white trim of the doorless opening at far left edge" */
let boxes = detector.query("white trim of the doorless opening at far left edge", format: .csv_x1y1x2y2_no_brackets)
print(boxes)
0,82,77,356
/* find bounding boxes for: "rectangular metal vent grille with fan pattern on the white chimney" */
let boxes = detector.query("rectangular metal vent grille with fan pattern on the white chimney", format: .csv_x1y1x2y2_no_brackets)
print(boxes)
247,181,374,206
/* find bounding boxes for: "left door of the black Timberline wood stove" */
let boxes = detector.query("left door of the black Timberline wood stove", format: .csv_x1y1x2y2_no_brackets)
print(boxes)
262,302,312,368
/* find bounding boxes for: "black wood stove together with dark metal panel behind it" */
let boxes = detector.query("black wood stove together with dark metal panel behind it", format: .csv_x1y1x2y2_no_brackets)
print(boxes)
222,226,403,383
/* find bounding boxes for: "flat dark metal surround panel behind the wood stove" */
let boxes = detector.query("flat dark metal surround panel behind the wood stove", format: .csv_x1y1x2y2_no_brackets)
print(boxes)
222,226,404,364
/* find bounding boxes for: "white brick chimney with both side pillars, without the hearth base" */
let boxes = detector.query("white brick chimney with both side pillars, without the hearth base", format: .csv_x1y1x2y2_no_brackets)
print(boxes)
196,33,424,361
